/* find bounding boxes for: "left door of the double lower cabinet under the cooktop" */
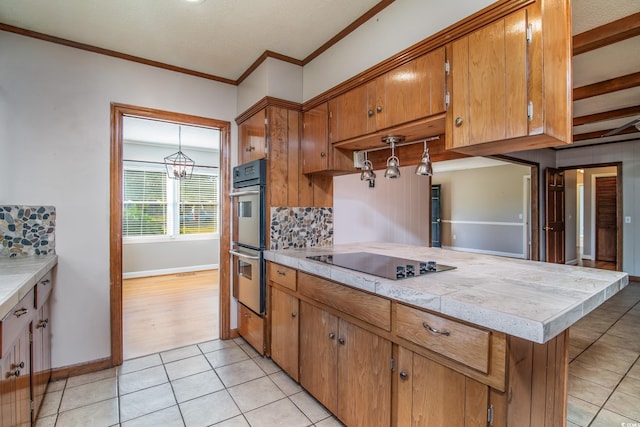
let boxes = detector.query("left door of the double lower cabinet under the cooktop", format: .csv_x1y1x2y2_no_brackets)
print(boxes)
300,301,340,414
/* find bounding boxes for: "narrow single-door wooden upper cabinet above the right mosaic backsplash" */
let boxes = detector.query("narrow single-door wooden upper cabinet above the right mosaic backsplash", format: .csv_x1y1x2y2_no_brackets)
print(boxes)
301,103,355,174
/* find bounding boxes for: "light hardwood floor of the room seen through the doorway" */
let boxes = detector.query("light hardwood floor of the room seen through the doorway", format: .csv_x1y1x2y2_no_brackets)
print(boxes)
122,270,220,360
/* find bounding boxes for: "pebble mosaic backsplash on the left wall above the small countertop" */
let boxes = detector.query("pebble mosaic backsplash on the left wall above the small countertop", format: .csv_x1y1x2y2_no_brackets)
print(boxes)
0,206,56,257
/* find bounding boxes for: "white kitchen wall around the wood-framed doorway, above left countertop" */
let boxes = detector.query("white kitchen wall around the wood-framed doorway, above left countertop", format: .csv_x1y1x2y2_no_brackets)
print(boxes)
0,31,237,367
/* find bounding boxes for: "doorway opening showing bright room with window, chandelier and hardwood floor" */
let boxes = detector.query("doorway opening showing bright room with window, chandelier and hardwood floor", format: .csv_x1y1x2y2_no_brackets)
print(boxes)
122,116,220,360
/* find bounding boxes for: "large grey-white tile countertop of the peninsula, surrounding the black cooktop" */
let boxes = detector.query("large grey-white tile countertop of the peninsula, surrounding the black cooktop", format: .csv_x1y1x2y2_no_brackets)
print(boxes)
265,242,629,343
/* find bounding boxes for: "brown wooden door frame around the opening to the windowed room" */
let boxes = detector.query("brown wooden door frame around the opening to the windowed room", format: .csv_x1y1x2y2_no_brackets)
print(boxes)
109,103,231,366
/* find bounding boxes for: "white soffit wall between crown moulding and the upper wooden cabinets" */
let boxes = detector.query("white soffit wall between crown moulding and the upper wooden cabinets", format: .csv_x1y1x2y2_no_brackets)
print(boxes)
303,0,494,101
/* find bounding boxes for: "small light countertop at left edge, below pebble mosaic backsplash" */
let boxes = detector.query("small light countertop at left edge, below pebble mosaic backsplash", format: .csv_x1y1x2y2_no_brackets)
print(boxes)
0,255,58,319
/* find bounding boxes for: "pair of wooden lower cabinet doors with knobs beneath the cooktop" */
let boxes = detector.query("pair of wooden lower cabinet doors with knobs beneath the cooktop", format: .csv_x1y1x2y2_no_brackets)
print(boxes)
300,301,391,427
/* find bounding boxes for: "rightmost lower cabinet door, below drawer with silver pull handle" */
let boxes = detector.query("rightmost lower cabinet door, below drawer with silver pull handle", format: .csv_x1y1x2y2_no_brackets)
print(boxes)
396,347,489,427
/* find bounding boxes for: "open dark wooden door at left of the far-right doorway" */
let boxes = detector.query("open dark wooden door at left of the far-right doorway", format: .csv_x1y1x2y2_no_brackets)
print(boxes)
544,168,565,264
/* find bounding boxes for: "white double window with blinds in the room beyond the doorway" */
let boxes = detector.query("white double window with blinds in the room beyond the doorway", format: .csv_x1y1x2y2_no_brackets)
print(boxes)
122,165,218,237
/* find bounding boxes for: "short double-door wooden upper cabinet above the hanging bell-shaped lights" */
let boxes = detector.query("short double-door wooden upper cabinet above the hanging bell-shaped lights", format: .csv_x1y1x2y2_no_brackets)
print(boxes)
329,48,445,143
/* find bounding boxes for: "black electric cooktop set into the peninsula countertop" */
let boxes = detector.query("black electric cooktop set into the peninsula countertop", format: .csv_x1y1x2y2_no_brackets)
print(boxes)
307,252,456,280
